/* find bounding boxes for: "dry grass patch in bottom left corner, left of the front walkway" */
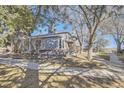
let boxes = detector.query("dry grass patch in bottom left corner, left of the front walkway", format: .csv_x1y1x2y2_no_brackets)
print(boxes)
0,64,25,88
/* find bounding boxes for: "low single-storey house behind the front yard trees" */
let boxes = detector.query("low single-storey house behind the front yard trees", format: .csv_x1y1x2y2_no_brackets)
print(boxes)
17,32,78,57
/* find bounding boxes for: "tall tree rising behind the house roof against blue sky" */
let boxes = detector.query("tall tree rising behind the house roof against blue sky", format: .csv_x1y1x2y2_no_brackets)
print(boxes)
38,5,66,33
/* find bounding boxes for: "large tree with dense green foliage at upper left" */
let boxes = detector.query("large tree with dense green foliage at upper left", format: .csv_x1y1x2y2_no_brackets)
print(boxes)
0,6,34,52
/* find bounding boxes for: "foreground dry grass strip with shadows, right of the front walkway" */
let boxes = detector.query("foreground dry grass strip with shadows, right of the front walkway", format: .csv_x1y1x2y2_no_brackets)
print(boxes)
39,73,124,88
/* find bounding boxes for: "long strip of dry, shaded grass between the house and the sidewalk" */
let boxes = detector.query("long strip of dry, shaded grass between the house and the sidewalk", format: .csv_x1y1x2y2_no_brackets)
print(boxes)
38,54,104,69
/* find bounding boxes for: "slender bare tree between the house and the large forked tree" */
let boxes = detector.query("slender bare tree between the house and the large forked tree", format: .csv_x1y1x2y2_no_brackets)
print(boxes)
60,6,84,53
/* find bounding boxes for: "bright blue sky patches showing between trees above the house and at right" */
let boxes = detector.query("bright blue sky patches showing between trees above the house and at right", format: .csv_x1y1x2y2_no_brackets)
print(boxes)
32,24,116,48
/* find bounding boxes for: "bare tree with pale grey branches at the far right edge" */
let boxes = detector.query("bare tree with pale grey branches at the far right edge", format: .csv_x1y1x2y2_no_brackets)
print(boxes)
104,15,124,53
